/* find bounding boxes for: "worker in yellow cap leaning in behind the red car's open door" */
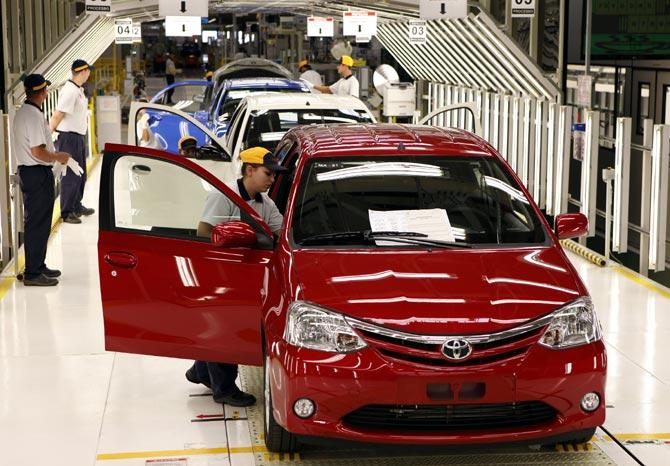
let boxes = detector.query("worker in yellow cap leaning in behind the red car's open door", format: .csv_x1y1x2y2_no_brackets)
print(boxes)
186,147,286,407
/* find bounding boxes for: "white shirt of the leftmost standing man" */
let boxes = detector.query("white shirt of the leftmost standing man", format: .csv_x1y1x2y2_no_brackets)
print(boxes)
12,102,56,166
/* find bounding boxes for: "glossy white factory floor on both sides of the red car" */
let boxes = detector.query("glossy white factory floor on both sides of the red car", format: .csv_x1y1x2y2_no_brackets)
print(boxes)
0,161,670,466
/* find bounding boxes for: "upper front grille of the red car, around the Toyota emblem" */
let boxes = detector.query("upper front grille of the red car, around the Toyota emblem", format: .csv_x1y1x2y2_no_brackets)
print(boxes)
354,323,545,367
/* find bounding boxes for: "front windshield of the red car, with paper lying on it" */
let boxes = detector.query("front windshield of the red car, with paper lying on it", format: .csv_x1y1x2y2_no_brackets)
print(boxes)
292,156,548,246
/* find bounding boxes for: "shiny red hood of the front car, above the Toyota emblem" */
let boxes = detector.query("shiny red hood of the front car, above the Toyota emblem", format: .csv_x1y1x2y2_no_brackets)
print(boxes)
291,247,586,335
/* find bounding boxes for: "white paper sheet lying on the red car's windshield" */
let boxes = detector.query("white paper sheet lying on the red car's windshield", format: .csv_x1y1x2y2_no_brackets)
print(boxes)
368,209,456,246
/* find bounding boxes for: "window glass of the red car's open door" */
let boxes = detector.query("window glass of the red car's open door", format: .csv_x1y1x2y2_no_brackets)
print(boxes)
113,155,261,242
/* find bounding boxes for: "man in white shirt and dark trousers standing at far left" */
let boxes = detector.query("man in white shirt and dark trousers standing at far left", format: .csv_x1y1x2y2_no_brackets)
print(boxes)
12,74,70,286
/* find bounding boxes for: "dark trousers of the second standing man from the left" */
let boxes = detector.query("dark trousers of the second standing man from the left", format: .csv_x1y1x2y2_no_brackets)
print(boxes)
56,132,86,218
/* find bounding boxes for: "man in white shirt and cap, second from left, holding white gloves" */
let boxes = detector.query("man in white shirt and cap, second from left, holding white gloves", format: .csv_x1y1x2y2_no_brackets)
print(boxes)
49,60,95,223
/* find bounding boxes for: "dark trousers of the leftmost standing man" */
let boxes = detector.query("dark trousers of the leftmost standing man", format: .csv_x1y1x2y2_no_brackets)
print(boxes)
19,165,55,279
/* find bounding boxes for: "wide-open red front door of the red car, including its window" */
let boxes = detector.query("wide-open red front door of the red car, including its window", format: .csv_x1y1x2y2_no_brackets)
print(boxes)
98,144,273,365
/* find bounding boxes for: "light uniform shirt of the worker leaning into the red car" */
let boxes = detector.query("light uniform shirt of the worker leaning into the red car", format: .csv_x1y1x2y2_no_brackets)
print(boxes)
200,179,284,233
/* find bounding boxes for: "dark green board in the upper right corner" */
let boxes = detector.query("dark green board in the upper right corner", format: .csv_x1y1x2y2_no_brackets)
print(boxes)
591,0,670,58
